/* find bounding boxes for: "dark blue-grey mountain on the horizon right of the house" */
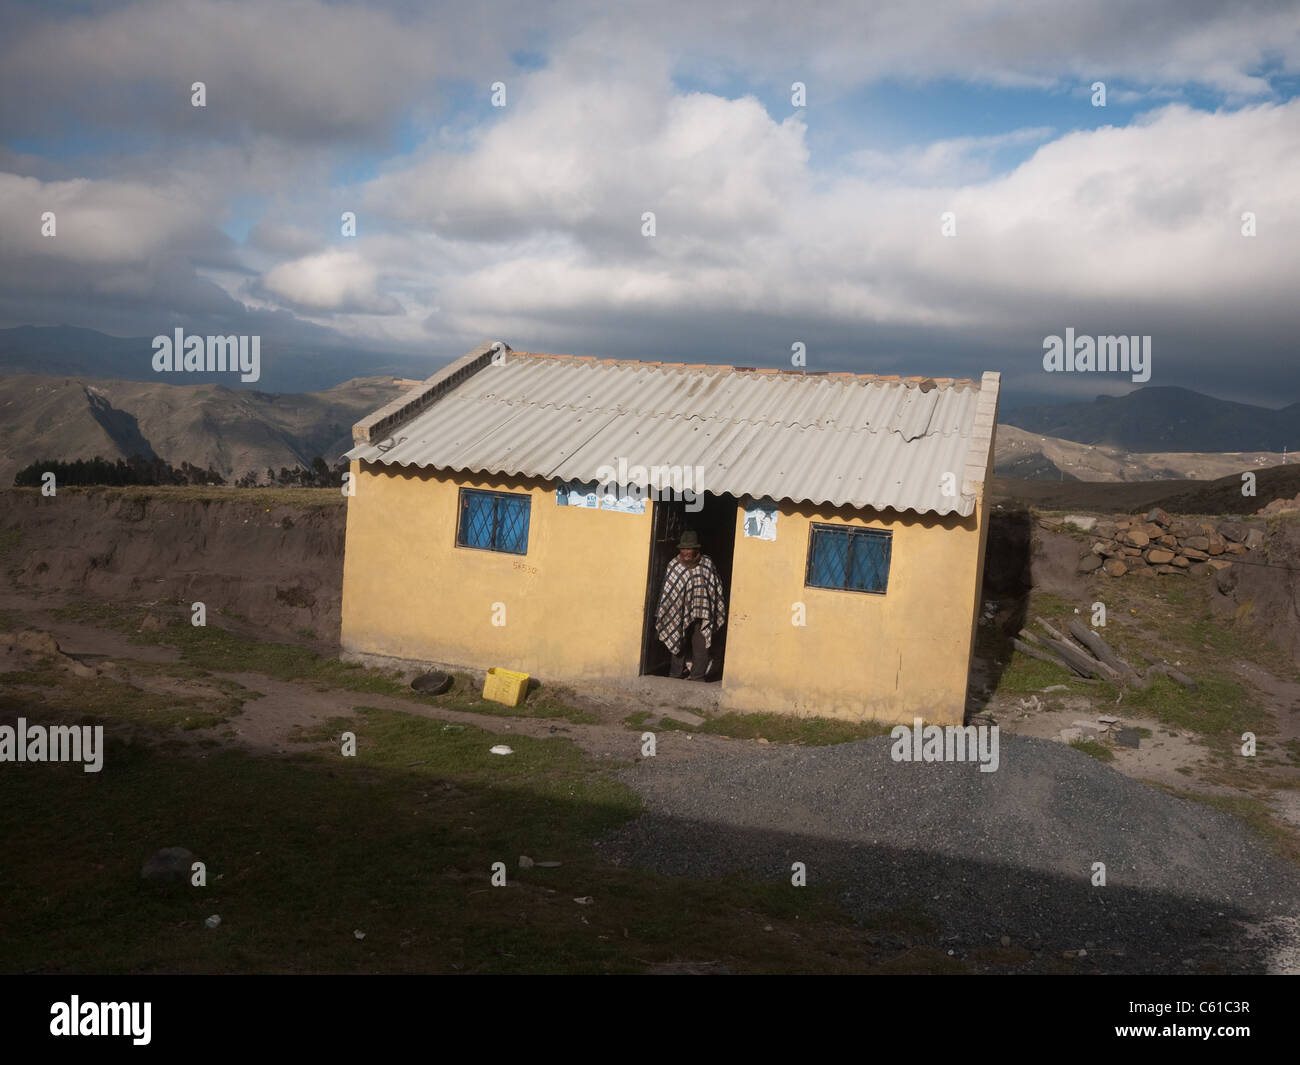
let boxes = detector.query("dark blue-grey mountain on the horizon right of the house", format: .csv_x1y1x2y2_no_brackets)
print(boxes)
998,388,1300,453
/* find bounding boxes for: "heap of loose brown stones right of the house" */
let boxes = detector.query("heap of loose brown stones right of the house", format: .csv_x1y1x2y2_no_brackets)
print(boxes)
1079,507,1264,577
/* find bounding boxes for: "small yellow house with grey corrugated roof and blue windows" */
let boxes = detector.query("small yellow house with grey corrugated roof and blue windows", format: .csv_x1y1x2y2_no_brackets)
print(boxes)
341,343,1000,724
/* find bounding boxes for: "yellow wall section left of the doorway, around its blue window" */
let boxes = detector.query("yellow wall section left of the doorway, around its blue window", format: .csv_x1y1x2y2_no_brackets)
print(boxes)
342,462,650,679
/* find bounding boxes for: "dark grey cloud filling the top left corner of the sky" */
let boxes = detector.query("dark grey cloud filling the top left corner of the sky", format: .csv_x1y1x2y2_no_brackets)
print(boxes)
0,0,434,142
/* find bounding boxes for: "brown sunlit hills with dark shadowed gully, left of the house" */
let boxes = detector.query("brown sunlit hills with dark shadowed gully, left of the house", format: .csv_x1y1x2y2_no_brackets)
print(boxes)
0,375,408,485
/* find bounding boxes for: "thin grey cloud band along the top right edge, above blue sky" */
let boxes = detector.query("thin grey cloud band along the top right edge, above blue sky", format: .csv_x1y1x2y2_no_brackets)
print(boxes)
644,0,1300,99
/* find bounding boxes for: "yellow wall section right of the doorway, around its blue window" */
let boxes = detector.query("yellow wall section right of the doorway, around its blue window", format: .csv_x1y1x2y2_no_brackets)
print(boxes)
722,494,982,724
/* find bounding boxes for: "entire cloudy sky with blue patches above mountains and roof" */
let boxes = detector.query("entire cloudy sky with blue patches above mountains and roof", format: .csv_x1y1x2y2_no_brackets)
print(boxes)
0,0,1300,406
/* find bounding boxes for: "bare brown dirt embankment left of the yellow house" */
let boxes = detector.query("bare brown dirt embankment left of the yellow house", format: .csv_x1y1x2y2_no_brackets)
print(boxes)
0,489,347,644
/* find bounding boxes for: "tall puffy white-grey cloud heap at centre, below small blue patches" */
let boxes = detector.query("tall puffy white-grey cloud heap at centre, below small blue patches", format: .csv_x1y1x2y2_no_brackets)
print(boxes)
365,42,807,247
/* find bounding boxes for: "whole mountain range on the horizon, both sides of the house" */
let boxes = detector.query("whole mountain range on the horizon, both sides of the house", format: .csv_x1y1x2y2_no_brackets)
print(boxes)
0,326,1300,485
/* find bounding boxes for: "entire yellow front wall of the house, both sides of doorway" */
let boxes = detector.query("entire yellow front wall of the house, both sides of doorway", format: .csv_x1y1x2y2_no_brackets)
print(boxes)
342,462,987,724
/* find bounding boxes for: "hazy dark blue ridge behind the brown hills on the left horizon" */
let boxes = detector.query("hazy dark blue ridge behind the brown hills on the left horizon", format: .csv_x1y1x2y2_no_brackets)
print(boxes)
0,322,436,393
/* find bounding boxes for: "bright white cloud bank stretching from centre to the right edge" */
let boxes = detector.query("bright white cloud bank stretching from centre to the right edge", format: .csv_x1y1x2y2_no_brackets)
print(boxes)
345,31,1300,403
